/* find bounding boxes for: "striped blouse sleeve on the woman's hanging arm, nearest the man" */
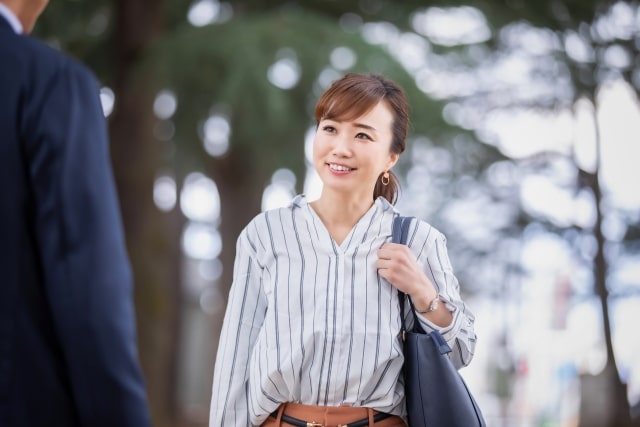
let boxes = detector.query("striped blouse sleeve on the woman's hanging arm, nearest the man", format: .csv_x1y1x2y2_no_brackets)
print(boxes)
209,227,267,427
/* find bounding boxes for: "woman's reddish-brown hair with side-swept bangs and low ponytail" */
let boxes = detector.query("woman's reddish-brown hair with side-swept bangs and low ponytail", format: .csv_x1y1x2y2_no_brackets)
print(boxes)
315,73,409,204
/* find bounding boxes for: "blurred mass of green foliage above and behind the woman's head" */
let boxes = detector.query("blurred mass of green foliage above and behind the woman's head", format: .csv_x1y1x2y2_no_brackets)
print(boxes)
144,8,456,182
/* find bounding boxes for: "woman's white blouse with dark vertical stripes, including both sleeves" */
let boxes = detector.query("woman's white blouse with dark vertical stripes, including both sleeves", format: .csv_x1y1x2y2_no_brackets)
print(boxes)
209,195,475,427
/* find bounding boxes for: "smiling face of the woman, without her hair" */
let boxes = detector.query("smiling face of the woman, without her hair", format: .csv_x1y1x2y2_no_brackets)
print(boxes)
313,101,398,198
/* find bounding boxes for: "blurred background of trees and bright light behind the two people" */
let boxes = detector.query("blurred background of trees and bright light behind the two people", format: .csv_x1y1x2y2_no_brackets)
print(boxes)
35,0,640,427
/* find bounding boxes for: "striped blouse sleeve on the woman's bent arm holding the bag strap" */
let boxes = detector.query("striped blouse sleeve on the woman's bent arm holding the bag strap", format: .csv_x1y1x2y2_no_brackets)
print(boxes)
409,227,476,369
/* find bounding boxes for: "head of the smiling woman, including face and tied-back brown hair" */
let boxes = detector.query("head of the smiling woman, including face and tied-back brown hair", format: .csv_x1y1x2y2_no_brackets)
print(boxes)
313,74,409,204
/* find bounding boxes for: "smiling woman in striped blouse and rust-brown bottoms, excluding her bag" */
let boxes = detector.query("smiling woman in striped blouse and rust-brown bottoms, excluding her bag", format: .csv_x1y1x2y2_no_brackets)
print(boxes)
210,74,475,427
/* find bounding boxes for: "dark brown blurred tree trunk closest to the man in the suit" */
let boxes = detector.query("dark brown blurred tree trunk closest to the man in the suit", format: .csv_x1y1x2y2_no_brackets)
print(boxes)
109,0,180,427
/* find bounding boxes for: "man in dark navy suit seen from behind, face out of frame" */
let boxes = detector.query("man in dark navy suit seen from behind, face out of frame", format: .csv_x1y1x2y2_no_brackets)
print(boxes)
0,0,150,427
